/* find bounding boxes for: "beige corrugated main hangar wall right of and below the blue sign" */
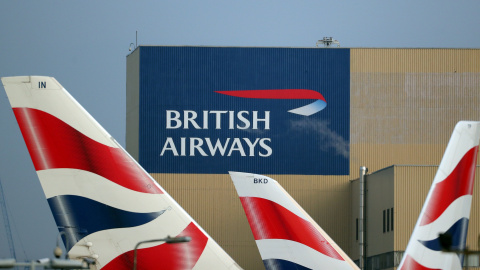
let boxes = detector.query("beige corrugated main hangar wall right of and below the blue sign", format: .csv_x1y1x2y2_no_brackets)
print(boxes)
127,49,480,269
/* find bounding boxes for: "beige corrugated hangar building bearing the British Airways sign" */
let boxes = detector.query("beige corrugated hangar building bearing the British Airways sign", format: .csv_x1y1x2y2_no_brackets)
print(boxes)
126,46,480,269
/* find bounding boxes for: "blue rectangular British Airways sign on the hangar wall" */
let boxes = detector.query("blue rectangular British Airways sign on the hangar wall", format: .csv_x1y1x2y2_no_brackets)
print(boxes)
139,46,350,175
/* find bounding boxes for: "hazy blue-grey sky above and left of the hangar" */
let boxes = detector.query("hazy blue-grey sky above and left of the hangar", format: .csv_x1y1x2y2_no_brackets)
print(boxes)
0,0,480,260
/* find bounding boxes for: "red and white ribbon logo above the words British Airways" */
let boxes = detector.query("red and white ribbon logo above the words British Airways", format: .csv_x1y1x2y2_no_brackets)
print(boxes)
215,89,327,116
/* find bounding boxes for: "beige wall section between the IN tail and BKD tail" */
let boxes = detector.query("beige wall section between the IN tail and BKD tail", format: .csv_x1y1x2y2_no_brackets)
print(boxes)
153,174,263,269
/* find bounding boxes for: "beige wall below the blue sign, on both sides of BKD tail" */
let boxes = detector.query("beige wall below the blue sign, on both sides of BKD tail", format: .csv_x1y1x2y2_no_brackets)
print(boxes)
152,174,355,269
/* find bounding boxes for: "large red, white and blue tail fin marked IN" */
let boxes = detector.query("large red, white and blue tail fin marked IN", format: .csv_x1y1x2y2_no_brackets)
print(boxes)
2,76,244,270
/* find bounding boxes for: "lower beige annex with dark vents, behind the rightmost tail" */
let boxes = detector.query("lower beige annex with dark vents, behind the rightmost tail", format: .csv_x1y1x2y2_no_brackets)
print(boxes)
350,165,480,270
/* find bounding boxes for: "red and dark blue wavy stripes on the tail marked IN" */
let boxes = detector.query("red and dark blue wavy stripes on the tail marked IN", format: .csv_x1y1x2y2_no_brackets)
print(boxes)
14,105,207,269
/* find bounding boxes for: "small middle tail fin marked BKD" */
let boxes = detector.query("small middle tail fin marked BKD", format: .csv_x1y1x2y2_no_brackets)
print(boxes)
230,172,359,270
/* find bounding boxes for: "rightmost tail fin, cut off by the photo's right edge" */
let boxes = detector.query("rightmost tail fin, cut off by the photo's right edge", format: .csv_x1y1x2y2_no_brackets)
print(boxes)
398,121,480,270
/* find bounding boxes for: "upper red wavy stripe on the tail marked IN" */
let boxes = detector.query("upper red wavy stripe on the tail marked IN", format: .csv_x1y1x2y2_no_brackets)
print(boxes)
13,108,163,194
